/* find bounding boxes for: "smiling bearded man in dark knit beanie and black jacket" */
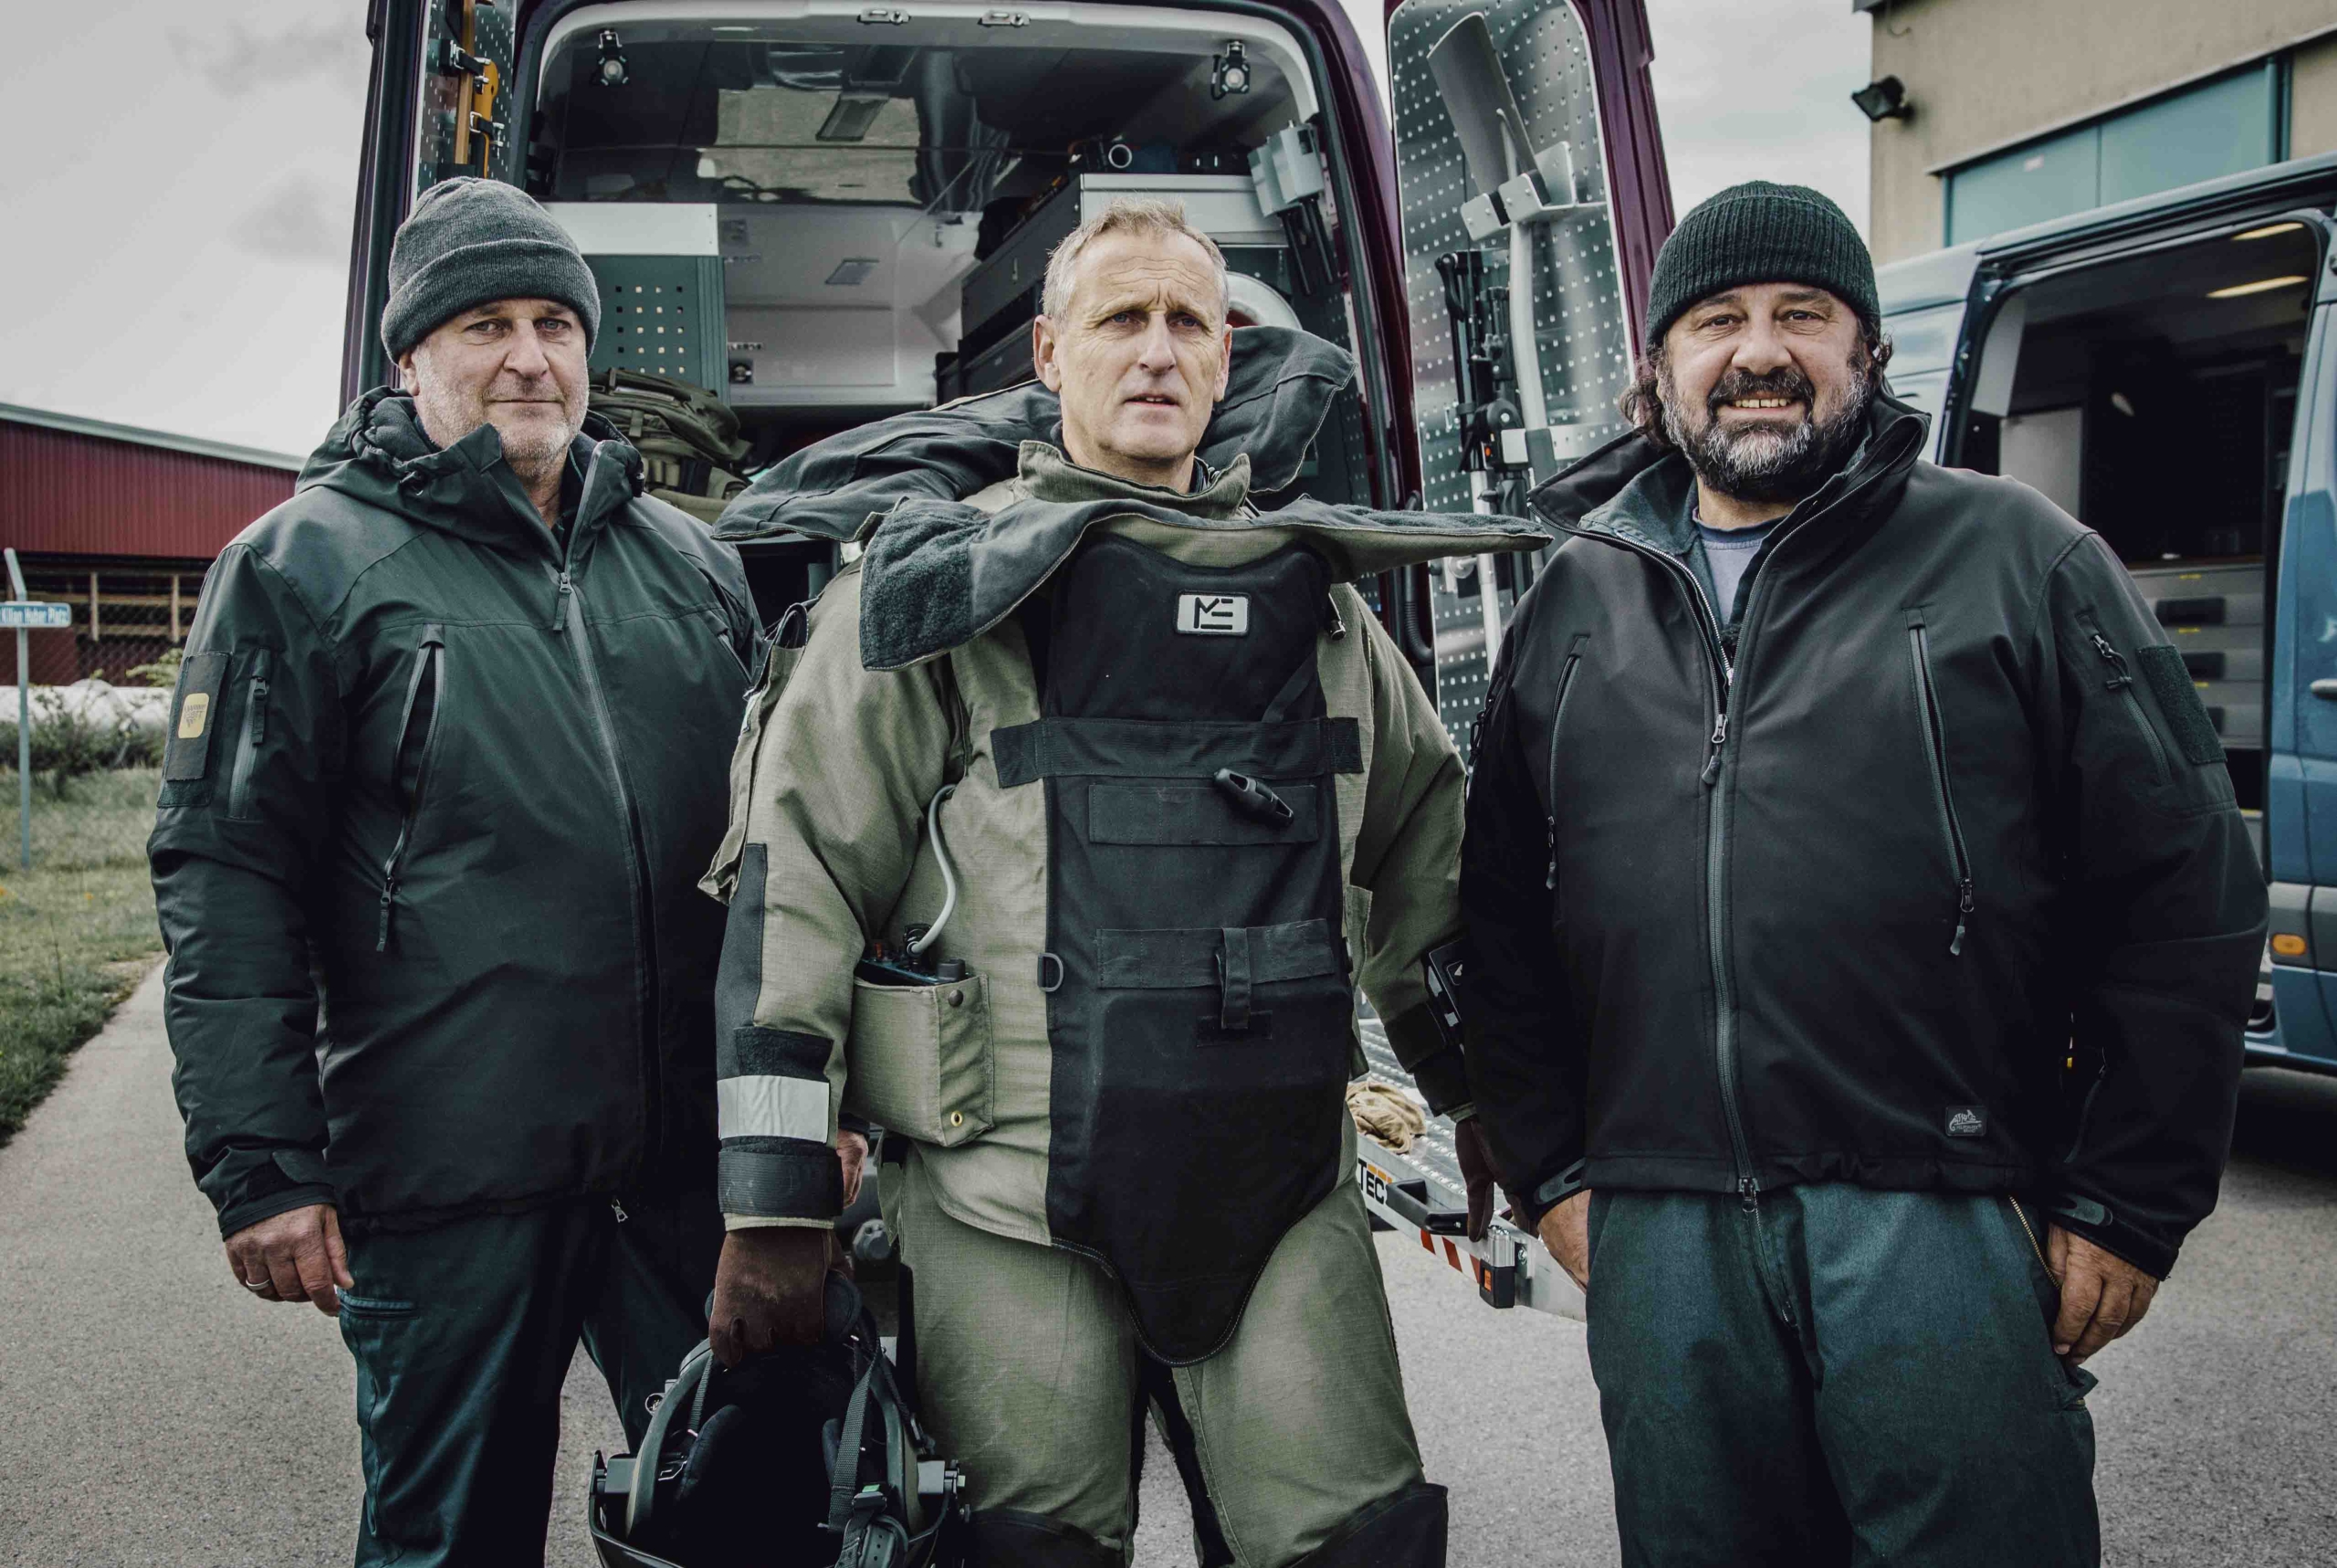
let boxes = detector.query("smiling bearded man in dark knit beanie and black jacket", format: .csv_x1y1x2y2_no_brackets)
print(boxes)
1461,183,2265,1568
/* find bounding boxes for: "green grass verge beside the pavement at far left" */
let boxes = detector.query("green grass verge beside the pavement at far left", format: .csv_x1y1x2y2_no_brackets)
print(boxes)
0,768,162,1143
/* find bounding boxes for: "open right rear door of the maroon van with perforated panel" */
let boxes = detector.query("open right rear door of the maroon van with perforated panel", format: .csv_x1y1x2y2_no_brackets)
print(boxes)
1389,0,1671,761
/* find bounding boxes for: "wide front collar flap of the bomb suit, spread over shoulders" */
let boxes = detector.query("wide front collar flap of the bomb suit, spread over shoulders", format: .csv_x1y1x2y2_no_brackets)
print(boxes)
860,442,1549,671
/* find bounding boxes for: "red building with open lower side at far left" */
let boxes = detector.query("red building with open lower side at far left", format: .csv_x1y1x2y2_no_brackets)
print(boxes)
0,404,301,687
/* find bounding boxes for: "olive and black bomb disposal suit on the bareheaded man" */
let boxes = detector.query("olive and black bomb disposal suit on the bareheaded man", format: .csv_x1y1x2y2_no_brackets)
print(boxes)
710,329,1547,1568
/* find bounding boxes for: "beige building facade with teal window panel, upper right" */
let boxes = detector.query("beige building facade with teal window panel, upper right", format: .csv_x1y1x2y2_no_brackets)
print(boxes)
1851,0,2337,262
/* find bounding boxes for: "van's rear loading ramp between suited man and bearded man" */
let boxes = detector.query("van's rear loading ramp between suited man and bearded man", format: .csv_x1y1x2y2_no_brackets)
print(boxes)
1356,1019,1582,1322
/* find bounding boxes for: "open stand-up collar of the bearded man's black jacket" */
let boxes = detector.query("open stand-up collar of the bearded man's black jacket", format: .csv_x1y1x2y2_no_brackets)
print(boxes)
1528,392,1931,556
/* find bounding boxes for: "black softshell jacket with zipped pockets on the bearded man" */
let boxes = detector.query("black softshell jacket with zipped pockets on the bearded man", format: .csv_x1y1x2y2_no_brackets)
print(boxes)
1461,397,2265,1273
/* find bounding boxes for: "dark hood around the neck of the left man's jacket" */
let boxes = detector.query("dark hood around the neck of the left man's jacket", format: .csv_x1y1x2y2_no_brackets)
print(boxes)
295,385,640,549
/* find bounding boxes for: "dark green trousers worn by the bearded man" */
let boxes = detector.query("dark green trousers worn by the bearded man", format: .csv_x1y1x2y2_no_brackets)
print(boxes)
1589,1185,2101,1568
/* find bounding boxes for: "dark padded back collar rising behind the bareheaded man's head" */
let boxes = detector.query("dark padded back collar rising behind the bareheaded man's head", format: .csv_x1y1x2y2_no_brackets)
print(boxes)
715,327,1356,539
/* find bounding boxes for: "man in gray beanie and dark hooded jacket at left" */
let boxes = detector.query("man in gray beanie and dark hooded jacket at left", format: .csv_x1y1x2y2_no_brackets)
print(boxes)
150,180,799,1568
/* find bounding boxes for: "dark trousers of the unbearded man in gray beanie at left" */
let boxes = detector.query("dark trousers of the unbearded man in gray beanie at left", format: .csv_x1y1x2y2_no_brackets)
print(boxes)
341,1194,722,1568
